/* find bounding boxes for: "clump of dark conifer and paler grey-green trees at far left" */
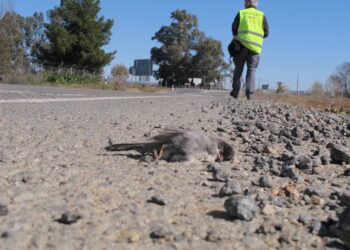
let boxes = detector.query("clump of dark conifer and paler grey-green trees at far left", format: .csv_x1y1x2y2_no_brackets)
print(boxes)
0,0,116,77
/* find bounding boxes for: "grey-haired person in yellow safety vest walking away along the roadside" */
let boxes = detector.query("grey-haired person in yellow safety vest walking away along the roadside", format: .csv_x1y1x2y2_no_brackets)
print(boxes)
230,0,269,100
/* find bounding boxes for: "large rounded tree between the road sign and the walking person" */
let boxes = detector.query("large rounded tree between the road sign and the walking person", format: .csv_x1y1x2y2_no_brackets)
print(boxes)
151,10,223,86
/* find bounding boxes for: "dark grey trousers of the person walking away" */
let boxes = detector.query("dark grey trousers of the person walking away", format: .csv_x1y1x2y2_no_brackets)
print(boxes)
232,46,260,98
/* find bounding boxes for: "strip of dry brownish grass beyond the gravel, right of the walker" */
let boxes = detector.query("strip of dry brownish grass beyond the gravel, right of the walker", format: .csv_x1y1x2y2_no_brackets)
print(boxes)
256,93,350,115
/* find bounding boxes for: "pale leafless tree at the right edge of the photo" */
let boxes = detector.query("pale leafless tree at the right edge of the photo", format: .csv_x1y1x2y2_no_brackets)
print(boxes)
327,62,350,98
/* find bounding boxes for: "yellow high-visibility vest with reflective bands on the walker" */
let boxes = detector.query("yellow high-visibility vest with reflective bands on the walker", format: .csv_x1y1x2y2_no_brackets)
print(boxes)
236,8,265,54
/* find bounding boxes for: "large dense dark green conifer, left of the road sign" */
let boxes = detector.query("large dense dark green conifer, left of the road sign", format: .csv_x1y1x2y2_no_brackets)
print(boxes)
34,0,116,71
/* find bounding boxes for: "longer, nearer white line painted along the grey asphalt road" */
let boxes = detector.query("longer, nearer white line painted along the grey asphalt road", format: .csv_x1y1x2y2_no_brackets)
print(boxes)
0,95,204,104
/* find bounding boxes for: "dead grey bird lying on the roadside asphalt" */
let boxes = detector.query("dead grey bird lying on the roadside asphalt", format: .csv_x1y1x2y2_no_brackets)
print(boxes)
105,129,234,162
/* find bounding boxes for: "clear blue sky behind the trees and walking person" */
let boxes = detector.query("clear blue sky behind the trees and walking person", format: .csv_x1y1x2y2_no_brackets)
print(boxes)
13,0,350,90
